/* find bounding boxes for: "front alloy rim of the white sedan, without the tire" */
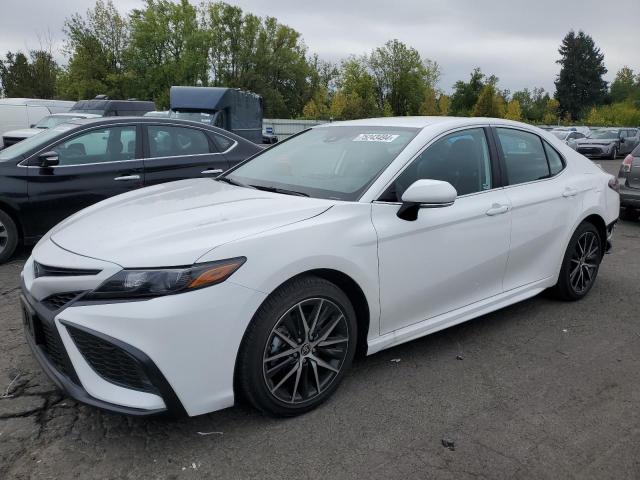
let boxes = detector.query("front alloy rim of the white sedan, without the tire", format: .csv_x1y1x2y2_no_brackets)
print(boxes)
263,298,350,405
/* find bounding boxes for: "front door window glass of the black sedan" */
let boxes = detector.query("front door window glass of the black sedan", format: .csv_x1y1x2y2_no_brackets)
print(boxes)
52,126,136,165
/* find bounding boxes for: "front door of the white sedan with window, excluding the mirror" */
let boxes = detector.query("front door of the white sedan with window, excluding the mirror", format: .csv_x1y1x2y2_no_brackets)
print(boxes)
372,128,511,334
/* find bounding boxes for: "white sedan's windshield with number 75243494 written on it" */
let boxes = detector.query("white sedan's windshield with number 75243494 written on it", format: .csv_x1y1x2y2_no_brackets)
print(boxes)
226,126,418,200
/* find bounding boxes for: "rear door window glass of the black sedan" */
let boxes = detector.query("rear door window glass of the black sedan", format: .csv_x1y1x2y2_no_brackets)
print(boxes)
147,125,211,158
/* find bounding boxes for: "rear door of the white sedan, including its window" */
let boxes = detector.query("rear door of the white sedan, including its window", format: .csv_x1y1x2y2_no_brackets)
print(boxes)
494,127,589,291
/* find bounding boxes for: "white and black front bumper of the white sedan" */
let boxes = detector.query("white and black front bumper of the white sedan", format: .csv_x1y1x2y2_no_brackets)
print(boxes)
22,240,265,416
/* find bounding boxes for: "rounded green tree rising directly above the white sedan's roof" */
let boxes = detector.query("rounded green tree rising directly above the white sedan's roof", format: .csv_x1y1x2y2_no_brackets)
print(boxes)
368,40,440,115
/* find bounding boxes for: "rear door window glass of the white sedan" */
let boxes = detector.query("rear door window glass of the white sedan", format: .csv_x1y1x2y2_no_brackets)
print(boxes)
496,128,550,185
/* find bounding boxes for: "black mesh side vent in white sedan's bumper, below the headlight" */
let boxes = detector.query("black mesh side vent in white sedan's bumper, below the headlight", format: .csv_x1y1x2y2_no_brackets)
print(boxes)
67,326,157,393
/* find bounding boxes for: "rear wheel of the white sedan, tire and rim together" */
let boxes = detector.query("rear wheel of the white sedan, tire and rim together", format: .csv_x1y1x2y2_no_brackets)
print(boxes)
553,222,603,301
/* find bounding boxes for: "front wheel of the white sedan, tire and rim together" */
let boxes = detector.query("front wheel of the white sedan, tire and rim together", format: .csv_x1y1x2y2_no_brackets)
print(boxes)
236,276,358,417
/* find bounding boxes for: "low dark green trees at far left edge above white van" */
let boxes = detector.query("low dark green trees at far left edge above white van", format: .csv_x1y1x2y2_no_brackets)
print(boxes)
0,50,59,98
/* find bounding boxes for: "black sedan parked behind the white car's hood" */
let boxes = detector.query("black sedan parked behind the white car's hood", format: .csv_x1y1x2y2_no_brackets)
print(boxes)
0,117,262,262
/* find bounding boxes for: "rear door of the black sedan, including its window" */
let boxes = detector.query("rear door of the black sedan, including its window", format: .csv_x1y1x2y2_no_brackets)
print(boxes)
144,124,229,185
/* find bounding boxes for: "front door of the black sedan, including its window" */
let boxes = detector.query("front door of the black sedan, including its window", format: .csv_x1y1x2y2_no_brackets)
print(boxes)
24,124,144,236
